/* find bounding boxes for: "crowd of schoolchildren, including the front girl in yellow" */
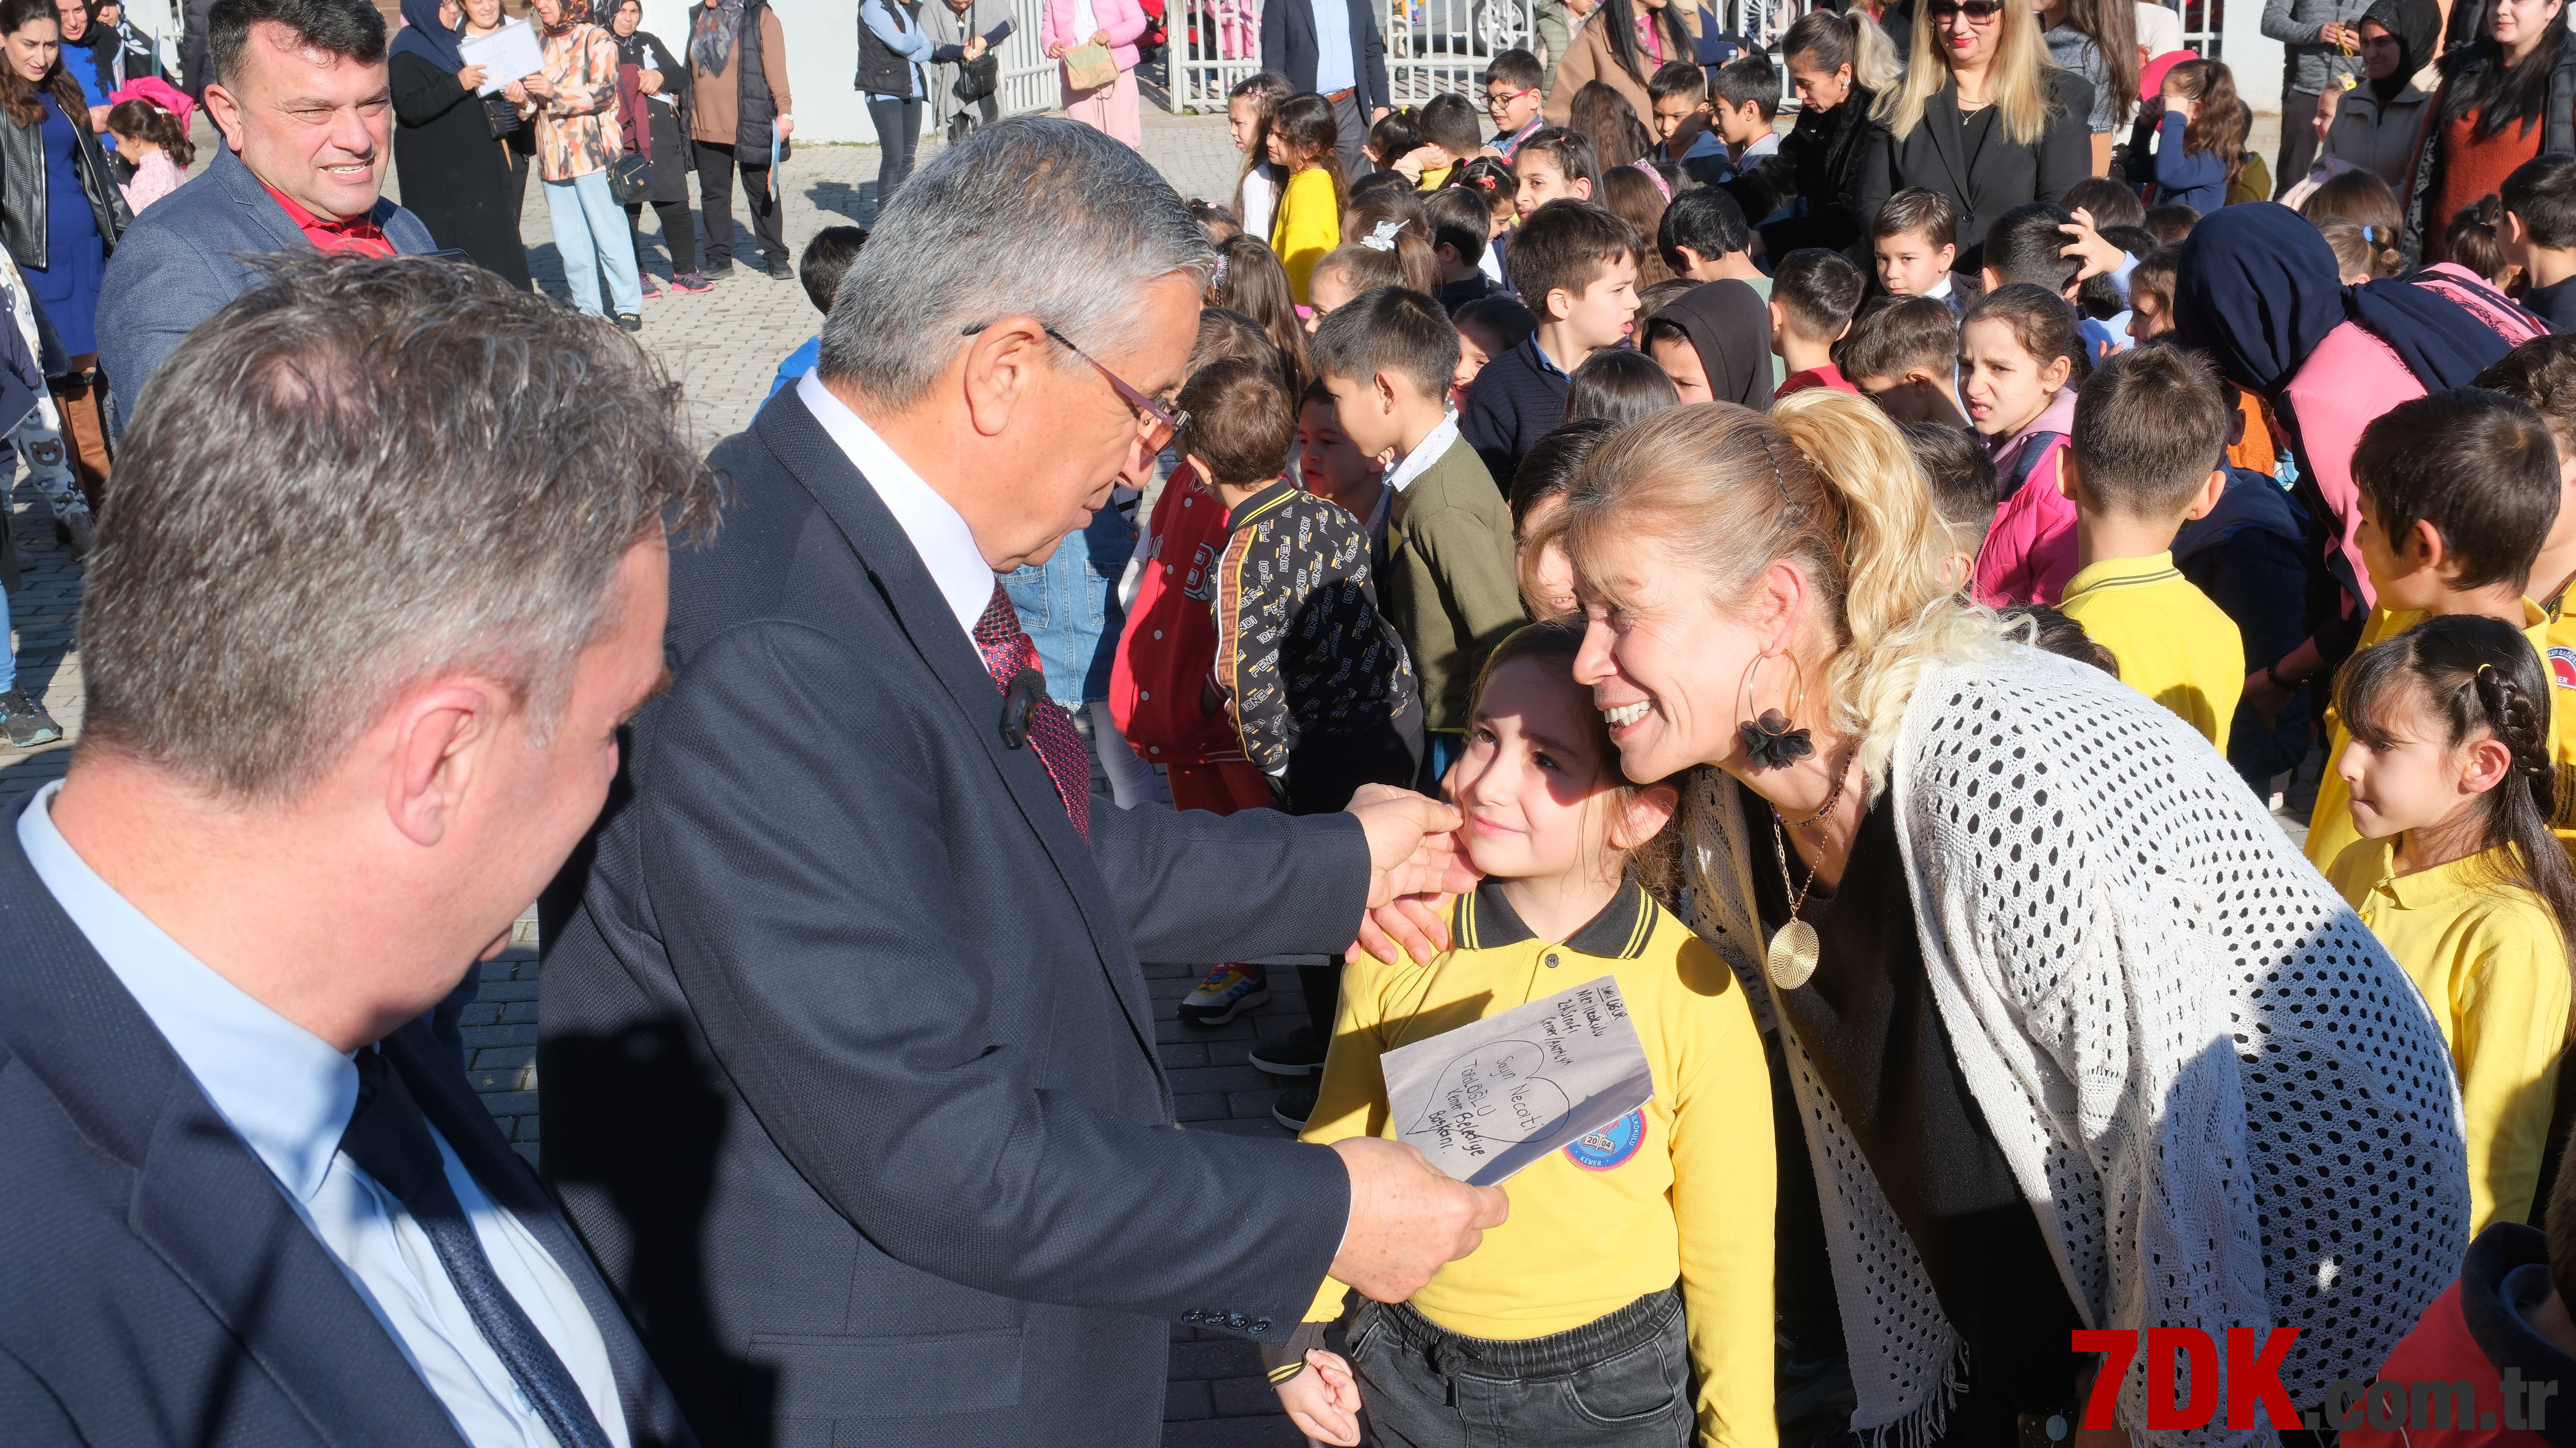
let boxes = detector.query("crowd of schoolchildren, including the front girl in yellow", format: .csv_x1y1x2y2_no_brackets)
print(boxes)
721,36,2576,1443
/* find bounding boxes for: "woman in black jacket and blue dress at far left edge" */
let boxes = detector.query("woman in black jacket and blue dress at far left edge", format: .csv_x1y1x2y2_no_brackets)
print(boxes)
0,0,134,505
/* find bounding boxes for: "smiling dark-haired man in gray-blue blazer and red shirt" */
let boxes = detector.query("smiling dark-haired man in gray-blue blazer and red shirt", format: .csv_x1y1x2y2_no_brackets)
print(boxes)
98,0,438,435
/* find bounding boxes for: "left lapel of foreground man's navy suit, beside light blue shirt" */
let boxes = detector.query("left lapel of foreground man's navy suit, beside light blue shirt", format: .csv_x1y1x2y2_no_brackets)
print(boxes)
0,817,461,1448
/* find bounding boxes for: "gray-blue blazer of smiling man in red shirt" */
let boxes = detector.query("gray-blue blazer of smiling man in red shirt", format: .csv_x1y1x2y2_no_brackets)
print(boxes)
98,150,438,433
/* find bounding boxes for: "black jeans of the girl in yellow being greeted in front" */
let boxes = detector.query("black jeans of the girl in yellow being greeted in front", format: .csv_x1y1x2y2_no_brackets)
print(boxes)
1350,1286,1697,1448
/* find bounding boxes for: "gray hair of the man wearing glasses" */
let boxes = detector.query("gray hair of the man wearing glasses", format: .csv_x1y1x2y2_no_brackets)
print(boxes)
822,119,1216,407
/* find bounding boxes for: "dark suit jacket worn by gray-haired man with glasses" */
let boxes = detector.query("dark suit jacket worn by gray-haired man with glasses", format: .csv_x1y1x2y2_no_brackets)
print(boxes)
538,389,1368,1448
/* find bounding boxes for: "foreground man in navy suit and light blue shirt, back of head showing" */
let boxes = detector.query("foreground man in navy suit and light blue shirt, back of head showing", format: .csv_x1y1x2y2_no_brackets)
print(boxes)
0,258,714,1448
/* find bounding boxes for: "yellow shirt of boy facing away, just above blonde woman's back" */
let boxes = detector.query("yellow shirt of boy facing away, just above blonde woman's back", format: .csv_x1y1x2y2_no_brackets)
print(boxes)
2058,551,2246,755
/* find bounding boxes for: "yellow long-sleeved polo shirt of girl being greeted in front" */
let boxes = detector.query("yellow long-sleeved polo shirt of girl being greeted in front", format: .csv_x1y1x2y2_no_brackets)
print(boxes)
1304,881,1777,1448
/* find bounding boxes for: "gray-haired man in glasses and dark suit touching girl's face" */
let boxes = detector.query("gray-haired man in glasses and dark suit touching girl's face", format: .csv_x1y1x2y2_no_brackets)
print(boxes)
538,119,1504,1448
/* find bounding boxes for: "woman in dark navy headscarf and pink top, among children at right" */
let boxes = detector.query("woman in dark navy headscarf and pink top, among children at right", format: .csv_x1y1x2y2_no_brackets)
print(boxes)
2174,206,2548,714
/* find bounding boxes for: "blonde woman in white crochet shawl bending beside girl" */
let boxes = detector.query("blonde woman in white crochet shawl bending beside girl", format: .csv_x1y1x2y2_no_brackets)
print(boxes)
1525,389,2468,1448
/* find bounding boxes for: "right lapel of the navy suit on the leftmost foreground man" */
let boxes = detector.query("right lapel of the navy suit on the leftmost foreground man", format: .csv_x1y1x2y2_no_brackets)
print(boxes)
384,1018,690,1448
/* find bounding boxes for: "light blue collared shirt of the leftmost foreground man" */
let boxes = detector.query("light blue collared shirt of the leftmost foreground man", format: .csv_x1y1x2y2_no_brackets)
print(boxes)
18,781,628,1448
